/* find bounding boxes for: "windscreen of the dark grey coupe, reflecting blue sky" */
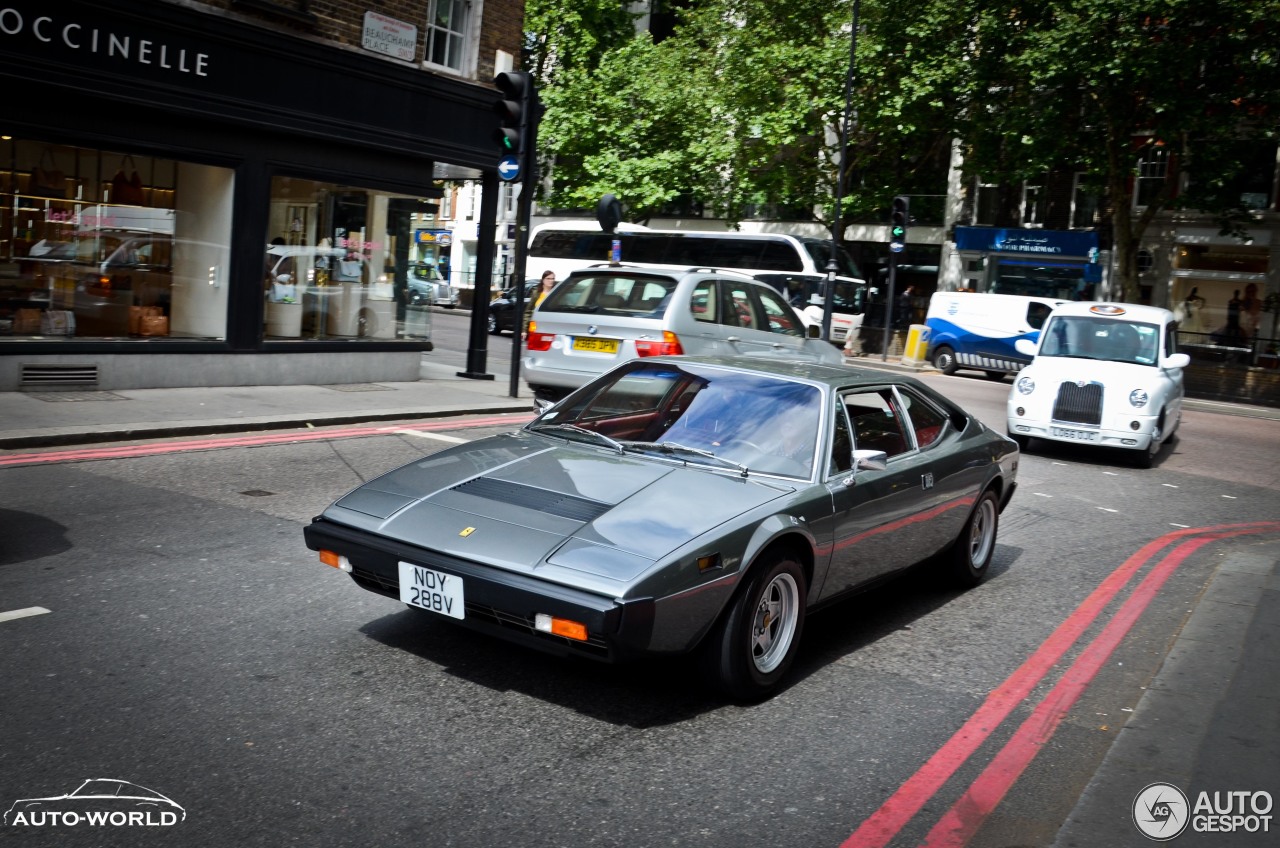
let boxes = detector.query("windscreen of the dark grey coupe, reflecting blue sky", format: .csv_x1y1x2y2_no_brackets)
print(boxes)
529,361,822,479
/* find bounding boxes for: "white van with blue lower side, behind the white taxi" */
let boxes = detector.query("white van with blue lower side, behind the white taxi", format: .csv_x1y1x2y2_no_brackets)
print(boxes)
924,292,1068,379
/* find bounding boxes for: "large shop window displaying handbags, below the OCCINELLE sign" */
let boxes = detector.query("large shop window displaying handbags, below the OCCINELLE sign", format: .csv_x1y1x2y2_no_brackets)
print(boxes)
0,138,234,341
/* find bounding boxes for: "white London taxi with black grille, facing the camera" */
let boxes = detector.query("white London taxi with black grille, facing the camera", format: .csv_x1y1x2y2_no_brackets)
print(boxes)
1007,302,1190,468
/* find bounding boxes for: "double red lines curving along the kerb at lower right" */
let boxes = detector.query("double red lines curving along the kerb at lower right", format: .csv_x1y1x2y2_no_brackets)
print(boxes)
841,521,1280,848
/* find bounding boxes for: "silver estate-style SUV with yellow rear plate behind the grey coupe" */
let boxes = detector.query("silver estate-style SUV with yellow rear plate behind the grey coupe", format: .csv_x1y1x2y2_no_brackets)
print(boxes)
521,265,844,397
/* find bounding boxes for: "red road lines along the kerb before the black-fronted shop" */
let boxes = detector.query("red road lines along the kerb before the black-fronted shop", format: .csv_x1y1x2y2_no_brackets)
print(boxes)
0,415,534,468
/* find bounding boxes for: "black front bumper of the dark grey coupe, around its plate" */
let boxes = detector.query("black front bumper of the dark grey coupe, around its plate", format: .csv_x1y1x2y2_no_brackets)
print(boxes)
303,519,654,662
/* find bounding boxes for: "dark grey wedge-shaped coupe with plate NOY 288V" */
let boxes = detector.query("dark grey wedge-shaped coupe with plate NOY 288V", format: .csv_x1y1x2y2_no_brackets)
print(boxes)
305,356,1019,699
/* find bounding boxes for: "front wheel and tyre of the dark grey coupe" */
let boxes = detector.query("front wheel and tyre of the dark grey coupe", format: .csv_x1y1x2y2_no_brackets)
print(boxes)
701,551,808,701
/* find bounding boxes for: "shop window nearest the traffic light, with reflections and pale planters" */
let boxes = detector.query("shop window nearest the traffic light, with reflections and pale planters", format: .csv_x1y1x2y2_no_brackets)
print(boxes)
262,177,449,341
